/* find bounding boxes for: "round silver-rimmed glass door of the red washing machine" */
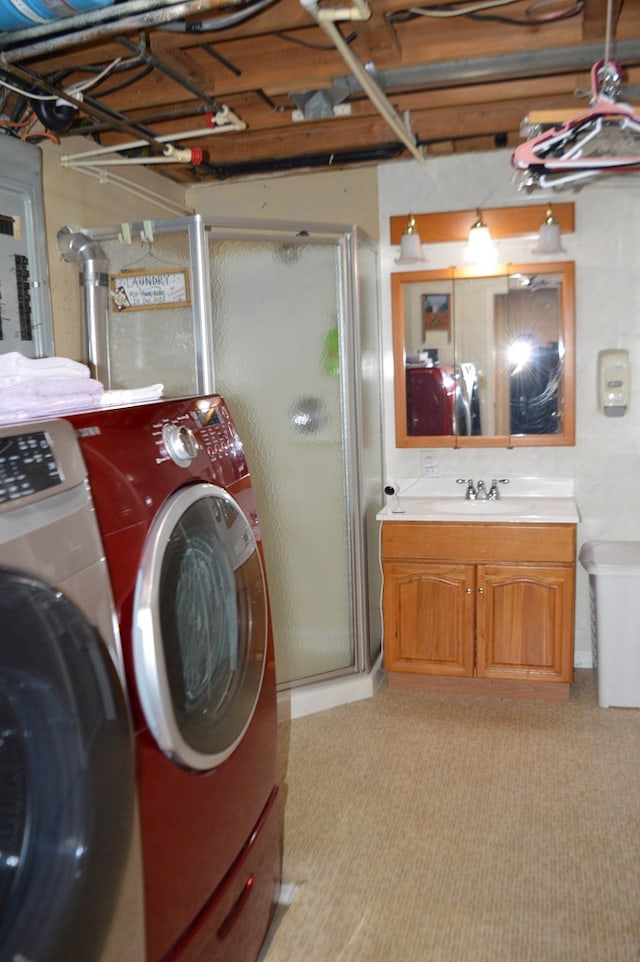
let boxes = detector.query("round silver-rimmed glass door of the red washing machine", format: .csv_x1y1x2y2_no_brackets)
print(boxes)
133,483,268,771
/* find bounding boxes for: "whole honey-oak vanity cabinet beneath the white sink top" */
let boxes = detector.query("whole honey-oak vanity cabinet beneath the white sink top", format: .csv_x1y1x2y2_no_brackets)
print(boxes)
382,521,576,700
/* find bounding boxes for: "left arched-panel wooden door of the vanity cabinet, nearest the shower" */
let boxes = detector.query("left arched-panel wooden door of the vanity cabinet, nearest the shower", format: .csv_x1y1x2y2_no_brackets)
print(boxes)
383,561,475,676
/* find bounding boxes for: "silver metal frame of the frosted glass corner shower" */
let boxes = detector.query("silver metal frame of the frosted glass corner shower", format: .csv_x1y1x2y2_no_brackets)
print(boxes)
83,214,384,689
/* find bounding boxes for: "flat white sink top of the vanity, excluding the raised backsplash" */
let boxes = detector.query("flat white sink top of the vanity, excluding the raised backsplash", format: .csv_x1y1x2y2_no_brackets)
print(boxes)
377,495,580,524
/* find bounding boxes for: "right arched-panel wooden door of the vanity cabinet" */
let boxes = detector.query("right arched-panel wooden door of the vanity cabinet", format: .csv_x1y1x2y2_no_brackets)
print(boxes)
476,565,574,682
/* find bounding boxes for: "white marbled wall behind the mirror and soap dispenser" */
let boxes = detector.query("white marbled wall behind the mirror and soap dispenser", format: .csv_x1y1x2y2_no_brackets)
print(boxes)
378,151,640,665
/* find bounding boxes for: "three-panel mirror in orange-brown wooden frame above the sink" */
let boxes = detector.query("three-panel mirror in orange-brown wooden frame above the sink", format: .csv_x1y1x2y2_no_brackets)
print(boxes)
391,261,575,448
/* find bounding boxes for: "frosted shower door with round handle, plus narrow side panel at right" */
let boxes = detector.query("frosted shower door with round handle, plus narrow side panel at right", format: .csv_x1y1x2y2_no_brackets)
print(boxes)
207,226,382,686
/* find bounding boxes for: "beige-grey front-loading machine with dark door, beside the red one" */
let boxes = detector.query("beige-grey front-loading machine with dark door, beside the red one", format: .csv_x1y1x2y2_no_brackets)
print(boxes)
0,420,144,962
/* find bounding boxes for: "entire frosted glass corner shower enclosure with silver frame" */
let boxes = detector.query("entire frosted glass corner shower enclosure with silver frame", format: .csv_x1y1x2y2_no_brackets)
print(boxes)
77,215,383,688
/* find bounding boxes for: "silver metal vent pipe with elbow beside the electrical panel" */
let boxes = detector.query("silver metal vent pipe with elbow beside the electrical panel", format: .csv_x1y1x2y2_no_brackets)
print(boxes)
58,227,111,388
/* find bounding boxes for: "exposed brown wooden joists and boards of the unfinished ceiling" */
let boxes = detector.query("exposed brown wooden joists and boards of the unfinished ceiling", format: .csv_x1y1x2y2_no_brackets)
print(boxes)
8,0,640,183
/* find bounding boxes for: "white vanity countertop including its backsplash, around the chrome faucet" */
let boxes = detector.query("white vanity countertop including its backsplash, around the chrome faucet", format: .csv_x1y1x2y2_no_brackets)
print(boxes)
376,478,580,524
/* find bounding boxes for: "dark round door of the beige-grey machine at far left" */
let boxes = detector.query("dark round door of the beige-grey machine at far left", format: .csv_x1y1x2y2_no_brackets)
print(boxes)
0,568,135,962
